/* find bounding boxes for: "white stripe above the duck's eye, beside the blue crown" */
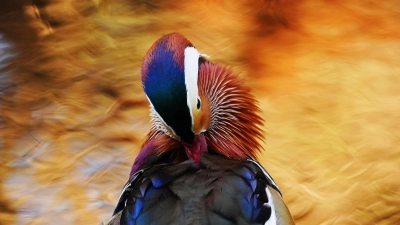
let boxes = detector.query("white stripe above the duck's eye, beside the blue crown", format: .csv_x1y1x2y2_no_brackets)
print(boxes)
184,47,203,126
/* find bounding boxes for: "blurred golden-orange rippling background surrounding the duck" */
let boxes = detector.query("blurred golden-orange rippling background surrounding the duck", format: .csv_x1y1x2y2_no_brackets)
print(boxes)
0,0,400,225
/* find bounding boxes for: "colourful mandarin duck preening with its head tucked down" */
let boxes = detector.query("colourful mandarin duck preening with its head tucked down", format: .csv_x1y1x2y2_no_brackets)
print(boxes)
109,33,294,225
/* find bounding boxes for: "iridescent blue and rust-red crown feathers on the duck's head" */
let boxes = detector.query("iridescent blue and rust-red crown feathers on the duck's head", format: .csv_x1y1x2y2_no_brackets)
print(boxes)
142,33,197,143
